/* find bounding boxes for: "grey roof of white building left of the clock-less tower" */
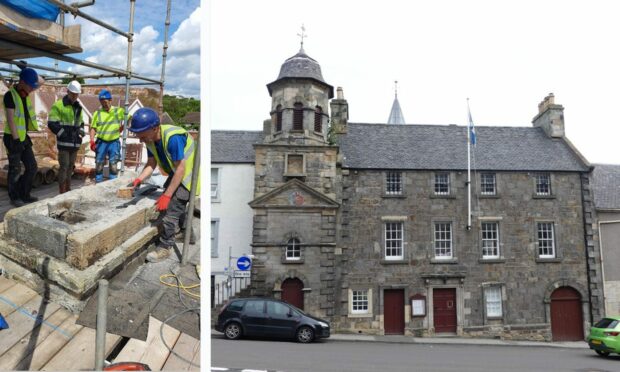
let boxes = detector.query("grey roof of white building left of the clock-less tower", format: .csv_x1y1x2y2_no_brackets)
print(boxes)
211,130,263,164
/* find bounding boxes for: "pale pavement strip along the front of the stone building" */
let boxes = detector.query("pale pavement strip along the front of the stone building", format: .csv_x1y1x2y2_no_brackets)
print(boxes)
211,329,590,349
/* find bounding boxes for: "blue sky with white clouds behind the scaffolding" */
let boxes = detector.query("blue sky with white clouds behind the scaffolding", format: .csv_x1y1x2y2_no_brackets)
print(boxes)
3,0,201,98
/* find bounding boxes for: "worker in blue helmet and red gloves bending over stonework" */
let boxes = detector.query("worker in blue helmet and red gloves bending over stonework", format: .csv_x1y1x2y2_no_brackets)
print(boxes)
129,107,200,262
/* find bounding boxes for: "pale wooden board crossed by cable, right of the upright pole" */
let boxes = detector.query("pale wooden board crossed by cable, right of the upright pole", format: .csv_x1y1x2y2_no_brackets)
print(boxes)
114,317,181,371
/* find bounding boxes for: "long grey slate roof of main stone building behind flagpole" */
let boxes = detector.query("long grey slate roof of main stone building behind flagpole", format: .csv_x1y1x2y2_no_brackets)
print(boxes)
337,123,588,171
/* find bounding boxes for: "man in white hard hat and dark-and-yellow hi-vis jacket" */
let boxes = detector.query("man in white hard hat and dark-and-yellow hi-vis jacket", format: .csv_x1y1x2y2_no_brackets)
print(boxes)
47,80,85,194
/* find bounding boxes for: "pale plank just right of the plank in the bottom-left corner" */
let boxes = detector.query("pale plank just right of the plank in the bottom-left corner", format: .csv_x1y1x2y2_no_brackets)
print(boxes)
14,315,81,371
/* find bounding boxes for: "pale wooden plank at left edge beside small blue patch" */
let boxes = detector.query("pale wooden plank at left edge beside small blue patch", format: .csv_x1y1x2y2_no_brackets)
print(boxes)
0,295,60,355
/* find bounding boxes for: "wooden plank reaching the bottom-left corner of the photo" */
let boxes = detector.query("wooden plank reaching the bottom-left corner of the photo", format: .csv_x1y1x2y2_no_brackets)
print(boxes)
0,308,75,370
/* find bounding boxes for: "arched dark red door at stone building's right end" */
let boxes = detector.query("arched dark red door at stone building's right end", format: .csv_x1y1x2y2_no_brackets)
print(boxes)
551,287,583,341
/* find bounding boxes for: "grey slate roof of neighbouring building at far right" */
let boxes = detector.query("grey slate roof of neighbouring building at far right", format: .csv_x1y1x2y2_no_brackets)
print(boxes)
592,164,620,209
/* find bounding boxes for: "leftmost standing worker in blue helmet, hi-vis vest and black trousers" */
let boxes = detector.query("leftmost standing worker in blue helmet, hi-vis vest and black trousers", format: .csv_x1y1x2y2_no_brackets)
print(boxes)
3,67,42,207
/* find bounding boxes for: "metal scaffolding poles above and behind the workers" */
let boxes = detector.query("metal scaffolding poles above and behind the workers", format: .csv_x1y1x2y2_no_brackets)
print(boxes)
0,0,171,174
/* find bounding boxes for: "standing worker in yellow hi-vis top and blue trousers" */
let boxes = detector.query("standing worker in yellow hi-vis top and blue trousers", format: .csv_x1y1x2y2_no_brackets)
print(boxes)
90,89,125,183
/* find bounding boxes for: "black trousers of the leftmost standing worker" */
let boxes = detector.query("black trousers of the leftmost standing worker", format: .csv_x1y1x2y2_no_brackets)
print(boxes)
2,134,37,200
